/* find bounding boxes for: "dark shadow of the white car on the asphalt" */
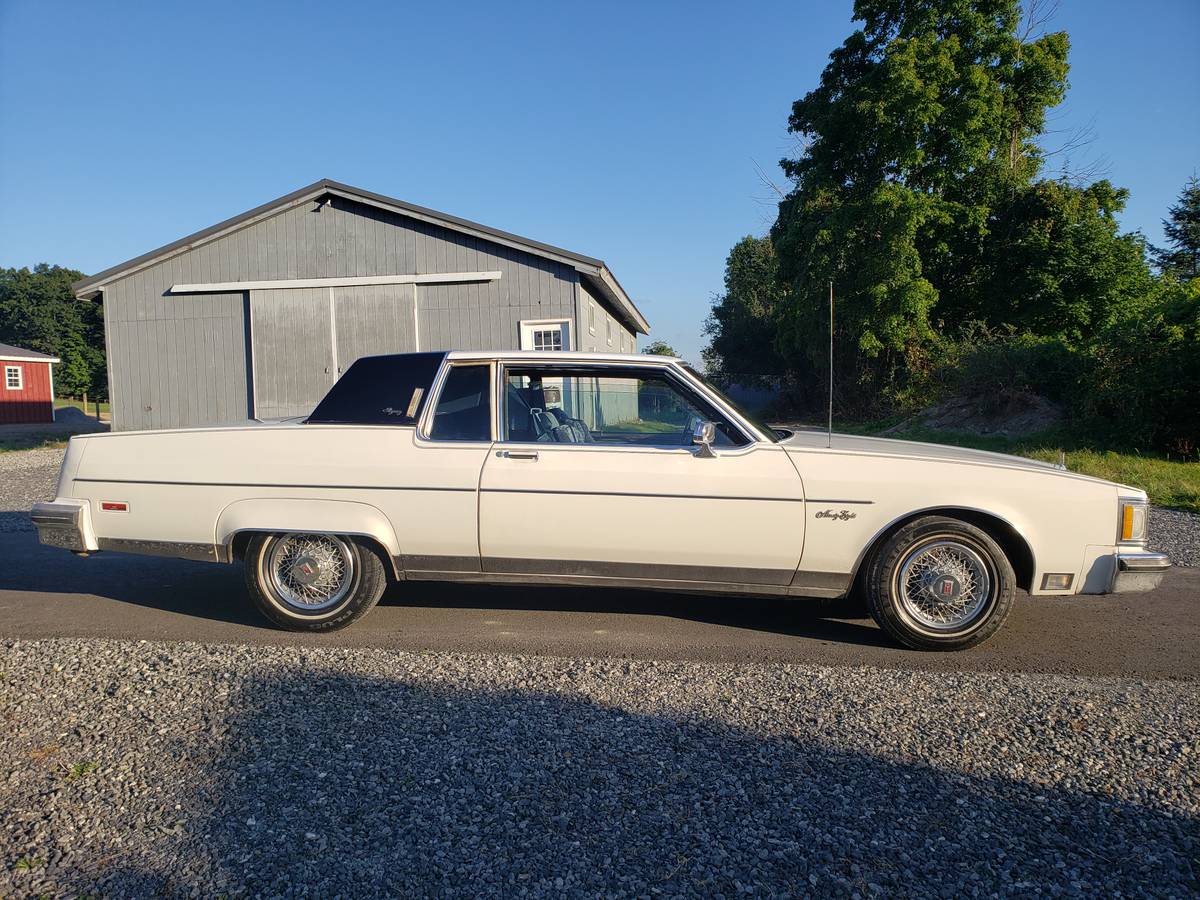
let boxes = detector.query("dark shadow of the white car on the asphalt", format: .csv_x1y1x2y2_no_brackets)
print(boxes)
0,532,892,647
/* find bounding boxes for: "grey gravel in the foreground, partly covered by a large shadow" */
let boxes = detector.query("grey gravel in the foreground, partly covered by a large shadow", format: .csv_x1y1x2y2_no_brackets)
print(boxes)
0,641,1200,896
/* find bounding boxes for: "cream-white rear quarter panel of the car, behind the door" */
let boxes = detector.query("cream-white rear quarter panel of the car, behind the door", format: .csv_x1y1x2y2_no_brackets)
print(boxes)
59,425,488,570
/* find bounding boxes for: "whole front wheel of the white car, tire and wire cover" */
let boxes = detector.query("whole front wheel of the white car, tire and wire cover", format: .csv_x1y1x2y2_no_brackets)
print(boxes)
866,516,1016,650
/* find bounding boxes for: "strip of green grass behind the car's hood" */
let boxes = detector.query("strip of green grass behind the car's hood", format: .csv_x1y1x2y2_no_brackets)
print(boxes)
859,424,1200,512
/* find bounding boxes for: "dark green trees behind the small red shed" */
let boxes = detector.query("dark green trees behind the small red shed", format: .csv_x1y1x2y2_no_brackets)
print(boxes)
0,263,107,397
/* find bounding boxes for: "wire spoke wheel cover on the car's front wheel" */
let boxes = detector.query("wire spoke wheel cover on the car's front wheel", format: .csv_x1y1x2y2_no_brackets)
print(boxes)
893,536,995,632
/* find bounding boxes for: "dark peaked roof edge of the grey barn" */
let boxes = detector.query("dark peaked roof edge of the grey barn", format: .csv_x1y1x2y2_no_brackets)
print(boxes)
71,179,650,334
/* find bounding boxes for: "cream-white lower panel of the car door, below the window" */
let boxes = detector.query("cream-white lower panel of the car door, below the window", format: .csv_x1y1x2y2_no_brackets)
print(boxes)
479,444,804,584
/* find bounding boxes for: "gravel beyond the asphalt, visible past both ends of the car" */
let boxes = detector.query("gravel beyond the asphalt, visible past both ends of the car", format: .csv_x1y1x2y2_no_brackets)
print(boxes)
0,450,1200,566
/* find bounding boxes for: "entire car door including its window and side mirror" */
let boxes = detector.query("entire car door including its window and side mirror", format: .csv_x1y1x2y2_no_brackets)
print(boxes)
479,361,804,586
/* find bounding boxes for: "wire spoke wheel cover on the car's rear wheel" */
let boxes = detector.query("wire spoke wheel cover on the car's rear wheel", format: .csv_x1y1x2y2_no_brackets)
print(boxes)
264,534,354,614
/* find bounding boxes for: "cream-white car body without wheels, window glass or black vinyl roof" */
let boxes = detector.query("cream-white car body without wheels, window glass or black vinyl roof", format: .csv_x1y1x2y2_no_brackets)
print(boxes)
34,353,1169,607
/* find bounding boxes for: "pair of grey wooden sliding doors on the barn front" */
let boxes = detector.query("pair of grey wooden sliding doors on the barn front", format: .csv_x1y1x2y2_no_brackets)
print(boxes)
250,284,418,419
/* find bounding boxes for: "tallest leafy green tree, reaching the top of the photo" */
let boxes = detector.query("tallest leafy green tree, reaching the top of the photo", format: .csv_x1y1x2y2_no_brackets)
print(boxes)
772,0,1068,415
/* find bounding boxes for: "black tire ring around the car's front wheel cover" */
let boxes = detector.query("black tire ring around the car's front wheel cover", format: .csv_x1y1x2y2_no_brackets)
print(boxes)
866,516,1016,650
